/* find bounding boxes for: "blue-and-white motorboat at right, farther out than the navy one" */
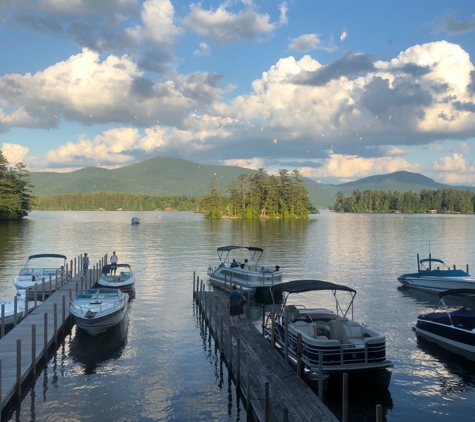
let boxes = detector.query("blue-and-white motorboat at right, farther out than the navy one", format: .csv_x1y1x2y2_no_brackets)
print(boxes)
398,255,475,293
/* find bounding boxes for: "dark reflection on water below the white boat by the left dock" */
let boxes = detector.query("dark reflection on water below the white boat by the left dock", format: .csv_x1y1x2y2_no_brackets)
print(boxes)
69,314,129,375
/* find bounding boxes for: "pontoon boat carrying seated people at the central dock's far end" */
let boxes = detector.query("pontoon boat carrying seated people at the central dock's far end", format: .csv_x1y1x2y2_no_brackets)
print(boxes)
208,246,282,295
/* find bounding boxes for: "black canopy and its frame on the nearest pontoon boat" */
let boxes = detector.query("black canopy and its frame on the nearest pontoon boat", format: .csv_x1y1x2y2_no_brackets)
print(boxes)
270,280,356,319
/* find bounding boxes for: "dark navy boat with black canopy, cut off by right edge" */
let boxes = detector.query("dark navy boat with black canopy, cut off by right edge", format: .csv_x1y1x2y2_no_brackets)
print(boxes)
412,288,475,360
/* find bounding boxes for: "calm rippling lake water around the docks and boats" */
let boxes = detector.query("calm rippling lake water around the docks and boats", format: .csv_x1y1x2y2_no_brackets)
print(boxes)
0,211,475,422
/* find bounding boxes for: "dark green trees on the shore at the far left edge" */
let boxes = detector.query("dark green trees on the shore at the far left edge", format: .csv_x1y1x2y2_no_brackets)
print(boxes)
0,150,33,220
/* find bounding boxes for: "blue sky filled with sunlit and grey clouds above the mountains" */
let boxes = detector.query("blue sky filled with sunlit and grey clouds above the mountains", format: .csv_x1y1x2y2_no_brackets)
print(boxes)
0,0,475,186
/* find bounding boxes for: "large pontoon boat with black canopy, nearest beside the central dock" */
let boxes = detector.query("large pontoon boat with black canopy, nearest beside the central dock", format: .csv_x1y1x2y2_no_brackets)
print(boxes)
265,280,393,388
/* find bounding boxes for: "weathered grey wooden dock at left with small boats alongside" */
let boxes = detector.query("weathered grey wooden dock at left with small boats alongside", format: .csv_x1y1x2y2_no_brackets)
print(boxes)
0,258,105,416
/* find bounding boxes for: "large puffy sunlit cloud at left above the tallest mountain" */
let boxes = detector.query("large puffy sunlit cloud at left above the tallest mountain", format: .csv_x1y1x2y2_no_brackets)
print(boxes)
0,50,225,129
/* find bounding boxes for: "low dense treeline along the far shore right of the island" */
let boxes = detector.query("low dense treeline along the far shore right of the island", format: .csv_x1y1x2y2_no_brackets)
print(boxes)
330,188,475,214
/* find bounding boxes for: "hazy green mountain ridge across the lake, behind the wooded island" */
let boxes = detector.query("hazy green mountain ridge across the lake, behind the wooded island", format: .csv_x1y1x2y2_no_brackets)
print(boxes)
31,161,475,208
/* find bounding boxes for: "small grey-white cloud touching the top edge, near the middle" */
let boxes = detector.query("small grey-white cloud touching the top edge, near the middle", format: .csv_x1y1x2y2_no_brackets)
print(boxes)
183,3,278,44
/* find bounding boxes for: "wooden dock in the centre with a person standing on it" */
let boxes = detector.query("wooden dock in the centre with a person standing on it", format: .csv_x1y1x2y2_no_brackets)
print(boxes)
193,282,338,422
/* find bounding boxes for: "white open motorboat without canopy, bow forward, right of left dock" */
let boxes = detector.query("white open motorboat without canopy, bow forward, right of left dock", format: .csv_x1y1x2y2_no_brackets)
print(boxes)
69,288,129,336
